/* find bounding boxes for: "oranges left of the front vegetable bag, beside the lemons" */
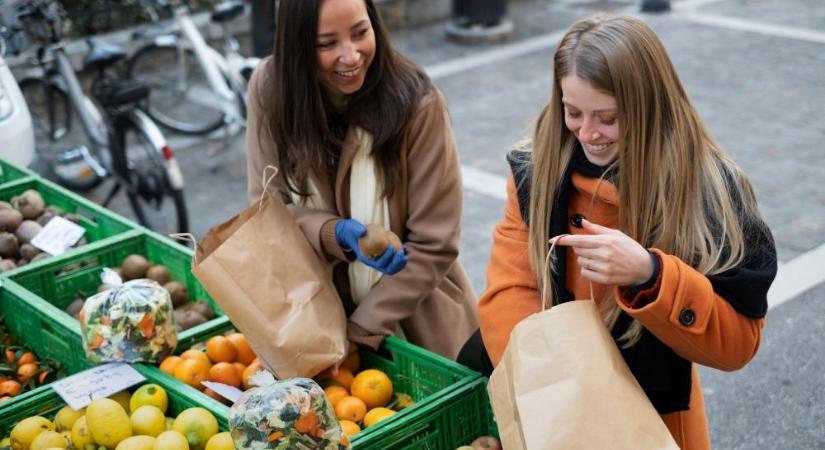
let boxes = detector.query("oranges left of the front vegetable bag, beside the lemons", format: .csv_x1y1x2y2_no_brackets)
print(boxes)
160,332,262,398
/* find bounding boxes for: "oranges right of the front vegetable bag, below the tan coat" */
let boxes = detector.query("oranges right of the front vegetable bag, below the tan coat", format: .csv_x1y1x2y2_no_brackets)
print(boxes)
315,353,415,436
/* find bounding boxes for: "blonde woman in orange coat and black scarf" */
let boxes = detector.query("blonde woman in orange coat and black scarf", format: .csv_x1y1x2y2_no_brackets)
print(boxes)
462,16,777,449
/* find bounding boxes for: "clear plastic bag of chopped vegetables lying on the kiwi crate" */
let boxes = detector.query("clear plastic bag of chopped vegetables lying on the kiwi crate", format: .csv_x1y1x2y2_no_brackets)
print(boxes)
78,269,178,364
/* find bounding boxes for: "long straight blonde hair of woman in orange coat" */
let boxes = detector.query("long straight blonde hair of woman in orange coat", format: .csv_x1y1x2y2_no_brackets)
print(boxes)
529,15,761,347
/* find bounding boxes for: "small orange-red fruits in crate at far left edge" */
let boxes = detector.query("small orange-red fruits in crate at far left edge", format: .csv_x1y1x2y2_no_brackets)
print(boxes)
0,316,61,403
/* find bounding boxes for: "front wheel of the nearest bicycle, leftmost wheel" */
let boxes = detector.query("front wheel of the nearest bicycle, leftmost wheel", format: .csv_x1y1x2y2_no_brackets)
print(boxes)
20,78,102,191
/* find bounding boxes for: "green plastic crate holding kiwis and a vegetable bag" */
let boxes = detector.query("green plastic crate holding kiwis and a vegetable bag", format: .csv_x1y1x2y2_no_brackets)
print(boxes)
0,230,231,373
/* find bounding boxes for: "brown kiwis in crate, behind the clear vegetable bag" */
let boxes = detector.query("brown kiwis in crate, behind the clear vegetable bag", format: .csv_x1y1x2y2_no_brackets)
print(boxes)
65,254,215,331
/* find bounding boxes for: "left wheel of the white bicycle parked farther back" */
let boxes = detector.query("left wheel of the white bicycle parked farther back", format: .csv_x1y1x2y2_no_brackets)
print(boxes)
128,44,224,134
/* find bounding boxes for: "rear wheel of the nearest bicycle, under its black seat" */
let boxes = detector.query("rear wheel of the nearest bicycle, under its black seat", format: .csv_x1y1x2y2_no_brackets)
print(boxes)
110,118,189,234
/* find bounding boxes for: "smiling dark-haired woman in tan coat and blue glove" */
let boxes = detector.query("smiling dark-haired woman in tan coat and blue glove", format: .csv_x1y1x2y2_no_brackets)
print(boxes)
246,0,478,358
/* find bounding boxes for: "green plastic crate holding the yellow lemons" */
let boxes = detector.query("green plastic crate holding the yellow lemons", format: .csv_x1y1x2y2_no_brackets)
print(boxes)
0,364,228,437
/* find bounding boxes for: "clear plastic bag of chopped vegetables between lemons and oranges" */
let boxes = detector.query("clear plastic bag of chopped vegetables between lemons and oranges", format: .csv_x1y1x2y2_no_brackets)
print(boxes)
229,372,350,450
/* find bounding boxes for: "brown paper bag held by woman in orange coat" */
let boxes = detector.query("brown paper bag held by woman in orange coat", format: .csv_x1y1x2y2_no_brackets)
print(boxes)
487,300,679,450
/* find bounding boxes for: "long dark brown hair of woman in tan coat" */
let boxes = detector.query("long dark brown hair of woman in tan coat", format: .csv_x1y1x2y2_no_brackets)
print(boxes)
262,0,430,196
